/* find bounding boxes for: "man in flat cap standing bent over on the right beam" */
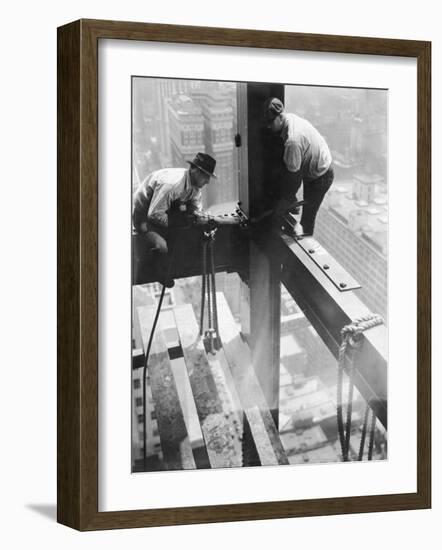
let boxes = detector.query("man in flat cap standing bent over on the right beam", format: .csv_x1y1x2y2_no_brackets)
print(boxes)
264,97,334,235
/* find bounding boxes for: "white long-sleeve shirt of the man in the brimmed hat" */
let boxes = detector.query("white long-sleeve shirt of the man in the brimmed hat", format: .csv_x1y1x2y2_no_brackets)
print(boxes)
133,168,202,230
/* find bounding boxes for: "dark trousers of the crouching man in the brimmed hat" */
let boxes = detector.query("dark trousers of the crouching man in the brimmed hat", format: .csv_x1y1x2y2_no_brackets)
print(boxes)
133,227,169,284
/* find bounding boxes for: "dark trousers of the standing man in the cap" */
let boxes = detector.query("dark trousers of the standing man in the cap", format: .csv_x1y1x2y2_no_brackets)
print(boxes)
284,166,335,235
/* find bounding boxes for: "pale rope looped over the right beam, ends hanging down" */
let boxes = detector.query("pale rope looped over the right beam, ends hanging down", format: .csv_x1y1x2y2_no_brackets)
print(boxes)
336,314,384,462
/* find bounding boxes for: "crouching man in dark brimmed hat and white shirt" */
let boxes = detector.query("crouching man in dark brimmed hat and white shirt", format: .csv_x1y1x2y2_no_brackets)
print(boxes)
132,153,216,287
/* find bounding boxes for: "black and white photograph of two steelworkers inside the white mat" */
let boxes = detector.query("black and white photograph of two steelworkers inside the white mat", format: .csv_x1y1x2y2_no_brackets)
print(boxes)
128,75,388,473
